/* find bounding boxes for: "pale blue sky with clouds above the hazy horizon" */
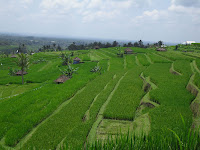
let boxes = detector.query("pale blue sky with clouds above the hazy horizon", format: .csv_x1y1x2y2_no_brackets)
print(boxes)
0,0,200,42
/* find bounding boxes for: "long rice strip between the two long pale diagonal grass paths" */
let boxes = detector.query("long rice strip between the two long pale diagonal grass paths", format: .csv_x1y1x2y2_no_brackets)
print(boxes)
24,57,121,149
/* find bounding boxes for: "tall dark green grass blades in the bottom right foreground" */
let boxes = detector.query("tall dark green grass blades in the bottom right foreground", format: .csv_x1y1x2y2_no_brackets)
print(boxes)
86,126,200,150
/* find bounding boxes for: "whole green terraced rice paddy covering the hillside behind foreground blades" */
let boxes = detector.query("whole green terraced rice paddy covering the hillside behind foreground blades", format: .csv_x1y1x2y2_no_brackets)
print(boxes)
0,48,200,150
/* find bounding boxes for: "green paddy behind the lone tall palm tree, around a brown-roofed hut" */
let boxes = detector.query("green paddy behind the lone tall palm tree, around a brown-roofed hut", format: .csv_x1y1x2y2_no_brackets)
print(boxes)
0,53,62,85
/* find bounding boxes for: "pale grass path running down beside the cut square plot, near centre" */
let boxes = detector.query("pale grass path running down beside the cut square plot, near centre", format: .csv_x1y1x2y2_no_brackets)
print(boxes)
88,72,127,144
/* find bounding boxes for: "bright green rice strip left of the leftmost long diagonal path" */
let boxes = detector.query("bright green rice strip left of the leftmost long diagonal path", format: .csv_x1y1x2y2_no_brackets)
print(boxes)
0,63,97,146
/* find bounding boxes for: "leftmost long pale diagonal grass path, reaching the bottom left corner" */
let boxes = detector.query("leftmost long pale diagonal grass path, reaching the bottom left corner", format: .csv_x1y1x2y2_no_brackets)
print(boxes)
2,87,85,150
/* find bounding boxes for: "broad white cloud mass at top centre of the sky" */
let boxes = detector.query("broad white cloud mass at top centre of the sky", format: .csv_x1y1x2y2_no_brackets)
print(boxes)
40,0,151,23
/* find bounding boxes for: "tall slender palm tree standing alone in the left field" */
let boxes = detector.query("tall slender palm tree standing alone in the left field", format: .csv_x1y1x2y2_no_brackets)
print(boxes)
16,53,29,84
